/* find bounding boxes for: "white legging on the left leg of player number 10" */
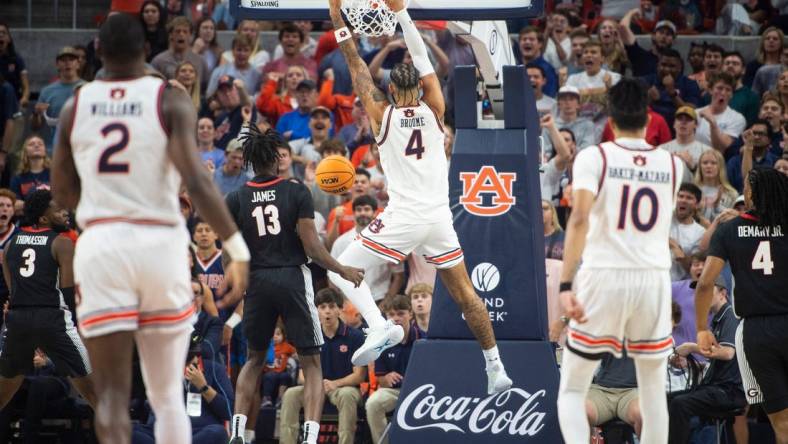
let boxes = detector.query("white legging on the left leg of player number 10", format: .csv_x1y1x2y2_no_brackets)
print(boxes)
558,351,600,443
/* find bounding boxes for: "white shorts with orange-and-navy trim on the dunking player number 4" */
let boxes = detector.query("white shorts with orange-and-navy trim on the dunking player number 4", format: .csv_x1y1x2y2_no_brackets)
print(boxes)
356,211,464,269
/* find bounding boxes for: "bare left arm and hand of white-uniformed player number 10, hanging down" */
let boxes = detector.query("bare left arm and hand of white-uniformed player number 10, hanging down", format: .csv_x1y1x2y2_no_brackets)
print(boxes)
560,190,594,324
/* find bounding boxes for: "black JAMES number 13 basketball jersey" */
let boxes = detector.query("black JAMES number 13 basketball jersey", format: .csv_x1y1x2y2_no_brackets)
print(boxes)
226,176,315,270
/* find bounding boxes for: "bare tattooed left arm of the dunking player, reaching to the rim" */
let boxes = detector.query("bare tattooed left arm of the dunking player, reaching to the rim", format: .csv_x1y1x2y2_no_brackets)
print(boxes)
329,0,389,137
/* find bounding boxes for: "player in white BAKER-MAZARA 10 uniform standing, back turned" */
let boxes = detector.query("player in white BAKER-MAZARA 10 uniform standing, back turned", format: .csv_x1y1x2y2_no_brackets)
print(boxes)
558,79,682,444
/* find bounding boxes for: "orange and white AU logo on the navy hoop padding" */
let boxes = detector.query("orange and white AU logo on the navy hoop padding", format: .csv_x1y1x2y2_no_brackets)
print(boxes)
460,165,517,217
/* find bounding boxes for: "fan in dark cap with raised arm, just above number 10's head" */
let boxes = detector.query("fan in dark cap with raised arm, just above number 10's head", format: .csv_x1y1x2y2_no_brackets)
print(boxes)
619,8,676,77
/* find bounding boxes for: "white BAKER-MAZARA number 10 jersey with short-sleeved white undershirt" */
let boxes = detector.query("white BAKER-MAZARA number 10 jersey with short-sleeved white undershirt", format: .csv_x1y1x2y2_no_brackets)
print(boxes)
572,138,683,270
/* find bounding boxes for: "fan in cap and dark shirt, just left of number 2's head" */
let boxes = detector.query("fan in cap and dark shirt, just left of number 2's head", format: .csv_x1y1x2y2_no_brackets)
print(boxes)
31,46,85,137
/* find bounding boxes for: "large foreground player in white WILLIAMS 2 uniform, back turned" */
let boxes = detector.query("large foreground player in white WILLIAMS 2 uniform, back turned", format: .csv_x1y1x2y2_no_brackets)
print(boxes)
52,14,249,444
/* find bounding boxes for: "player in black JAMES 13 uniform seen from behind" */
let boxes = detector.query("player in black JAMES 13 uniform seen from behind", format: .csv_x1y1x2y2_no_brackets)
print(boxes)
227,126,364,444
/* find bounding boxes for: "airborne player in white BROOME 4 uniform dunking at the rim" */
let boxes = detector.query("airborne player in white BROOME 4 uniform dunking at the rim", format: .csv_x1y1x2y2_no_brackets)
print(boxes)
329,0,512,394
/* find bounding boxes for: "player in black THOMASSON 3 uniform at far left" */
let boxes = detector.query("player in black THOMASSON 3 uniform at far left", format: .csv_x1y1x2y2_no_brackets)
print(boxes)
0,190,96,409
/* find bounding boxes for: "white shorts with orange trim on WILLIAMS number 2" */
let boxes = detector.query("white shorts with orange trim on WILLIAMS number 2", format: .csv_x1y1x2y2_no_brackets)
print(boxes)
74,223,194,338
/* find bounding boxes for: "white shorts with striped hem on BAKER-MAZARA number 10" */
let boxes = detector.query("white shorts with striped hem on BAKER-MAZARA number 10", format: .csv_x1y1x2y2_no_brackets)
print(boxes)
567,268,673,359
